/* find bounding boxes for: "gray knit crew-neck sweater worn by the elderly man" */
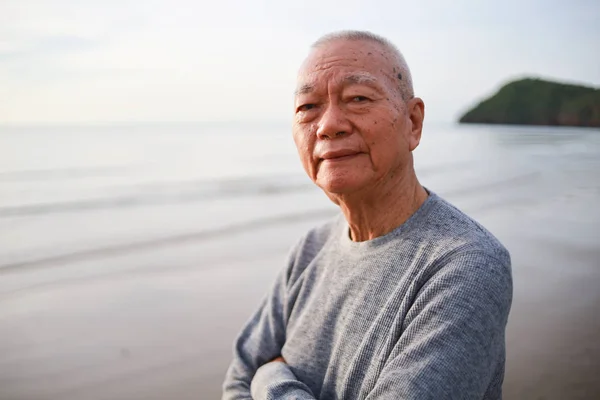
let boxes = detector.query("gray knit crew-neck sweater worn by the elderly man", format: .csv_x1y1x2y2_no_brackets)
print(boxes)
223,193,512,400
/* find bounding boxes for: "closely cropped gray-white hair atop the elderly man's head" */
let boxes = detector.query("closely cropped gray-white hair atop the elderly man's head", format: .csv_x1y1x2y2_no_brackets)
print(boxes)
311,30,415,100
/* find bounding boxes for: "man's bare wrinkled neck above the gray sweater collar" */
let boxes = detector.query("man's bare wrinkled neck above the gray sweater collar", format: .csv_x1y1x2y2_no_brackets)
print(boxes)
338,171,428,242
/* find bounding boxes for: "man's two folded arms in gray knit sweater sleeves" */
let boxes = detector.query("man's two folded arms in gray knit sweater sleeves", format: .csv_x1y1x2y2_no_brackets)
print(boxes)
223,254,512,400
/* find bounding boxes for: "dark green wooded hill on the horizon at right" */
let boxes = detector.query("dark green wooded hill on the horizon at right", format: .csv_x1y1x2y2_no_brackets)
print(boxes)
459,78,600,127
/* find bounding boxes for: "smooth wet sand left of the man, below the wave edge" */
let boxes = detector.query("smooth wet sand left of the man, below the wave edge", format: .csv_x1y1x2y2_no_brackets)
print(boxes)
0,221,322,399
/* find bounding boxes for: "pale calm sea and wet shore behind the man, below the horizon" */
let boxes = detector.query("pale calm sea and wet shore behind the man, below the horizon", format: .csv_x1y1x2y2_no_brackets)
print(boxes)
0,124,600,399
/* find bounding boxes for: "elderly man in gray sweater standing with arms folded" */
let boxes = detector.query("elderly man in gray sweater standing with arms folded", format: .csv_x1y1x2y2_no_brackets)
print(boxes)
223,31,512,400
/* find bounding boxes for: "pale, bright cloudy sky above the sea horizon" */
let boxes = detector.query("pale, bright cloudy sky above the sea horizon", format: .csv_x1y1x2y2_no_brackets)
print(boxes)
0,0,600,125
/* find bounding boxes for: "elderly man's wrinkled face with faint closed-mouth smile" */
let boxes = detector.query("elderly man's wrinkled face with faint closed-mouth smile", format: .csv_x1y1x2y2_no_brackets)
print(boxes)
293,40,423,194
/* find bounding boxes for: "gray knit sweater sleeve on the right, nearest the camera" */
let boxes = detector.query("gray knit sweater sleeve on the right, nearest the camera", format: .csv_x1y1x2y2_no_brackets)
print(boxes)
367,252,512,400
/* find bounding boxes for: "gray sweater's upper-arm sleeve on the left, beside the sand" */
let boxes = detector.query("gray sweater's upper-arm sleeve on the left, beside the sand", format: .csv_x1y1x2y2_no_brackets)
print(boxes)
222,241,312,400
